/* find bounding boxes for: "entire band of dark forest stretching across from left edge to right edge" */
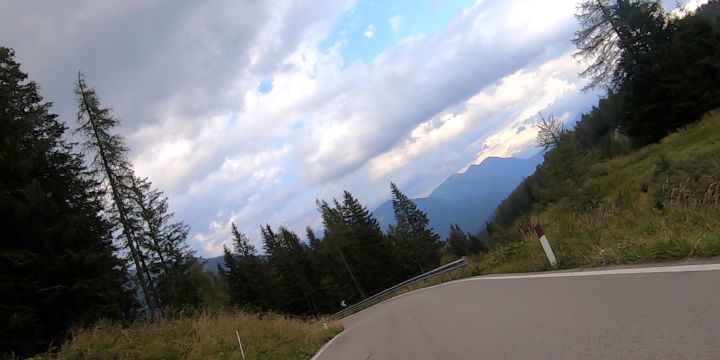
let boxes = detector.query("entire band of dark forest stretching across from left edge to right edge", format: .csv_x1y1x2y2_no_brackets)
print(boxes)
0,0,720,356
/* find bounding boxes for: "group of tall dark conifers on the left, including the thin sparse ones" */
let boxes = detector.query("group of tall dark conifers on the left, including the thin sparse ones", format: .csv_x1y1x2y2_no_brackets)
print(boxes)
0,47,217,356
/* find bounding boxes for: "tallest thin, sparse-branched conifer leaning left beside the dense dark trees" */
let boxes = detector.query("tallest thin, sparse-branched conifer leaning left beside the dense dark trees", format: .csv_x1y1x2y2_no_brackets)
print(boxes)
74,73,160,317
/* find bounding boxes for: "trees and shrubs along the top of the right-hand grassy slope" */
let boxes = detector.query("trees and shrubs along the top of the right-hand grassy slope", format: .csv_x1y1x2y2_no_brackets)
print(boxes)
480,0,720,247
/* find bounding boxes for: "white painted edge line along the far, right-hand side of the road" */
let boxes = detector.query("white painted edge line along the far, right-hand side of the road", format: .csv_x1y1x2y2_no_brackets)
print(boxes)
338,264,720,324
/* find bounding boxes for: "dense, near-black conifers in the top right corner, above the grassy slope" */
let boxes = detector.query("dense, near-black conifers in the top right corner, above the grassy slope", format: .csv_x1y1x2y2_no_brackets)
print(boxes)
621,1,720,147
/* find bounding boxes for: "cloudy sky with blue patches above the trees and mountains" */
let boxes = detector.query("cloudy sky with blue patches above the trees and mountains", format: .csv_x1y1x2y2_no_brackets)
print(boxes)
0,0,696,257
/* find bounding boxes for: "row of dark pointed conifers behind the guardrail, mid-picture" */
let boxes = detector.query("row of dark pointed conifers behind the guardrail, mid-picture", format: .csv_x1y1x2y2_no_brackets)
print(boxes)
218,183,486,316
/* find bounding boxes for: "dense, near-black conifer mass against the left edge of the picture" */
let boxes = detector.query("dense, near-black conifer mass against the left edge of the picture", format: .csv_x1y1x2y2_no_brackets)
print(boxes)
0,47,133,357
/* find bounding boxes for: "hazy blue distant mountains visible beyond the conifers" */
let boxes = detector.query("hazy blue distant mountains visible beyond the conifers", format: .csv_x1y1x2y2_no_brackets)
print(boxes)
373,153,543,239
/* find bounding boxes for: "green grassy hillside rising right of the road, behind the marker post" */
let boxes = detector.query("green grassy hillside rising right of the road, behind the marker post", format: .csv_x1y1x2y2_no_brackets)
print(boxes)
474,111,720,273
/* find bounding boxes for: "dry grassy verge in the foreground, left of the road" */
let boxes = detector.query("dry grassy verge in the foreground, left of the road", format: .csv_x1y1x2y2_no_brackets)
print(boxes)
23,312,342,360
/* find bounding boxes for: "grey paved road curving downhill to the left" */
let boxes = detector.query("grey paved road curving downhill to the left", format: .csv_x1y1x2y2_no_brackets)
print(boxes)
317,265,720,360
